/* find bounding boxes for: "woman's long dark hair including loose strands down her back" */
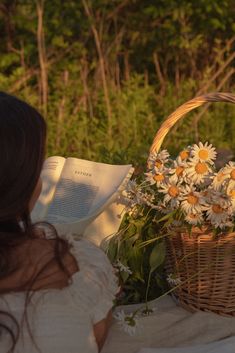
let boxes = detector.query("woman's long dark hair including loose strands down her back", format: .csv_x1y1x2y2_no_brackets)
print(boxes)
0,92,69,351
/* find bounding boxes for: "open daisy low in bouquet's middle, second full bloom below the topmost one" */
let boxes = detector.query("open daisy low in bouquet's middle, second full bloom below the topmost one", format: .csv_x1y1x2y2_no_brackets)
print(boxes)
181,185,204,214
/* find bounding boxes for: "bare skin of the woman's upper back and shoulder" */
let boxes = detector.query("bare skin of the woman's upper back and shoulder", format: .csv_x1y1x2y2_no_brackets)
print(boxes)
0,237,79,293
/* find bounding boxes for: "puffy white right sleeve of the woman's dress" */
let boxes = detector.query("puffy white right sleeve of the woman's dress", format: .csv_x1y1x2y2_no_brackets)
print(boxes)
65,235,119,324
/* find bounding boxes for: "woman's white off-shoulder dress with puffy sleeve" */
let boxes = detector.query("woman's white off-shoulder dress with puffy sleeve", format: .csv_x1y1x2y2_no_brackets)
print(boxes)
0,236,118,353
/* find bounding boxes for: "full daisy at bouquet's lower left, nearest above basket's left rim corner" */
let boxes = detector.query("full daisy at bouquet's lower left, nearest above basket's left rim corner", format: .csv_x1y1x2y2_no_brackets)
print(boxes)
158,177,182,209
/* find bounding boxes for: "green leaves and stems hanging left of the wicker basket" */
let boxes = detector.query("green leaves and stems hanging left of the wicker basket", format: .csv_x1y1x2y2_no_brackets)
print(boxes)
107,208,167,304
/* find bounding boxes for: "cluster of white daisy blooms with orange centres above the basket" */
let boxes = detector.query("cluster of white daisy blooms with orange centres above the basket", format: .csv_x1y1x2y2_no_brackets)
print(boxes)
127,142,235,231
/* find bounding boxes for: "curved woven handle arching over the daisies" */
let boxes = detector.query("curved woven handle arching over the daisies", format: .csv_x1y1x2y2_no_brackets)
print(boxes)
149,92,235,154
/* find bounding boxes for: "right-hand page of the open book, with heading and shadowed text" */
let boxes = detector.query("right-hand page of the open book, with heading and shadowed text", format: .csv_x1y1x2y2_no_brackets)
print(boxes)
46,158,132,225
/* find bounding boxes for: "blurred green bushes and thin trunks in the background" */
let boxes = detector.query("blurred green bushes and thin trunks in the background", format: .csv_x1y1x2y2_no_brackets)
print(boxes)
0,0,235,166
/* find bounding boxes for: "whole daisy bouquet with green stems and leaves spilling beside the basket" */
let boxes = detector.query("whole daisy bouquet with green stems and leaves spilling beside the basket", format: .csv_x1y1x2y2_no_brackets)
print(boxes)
108,142,235,325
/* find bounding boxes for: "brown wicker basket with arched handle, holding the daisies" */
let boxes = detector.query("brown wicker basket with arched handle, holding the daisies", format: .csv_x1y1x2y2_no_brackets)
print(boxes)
150,93,235,316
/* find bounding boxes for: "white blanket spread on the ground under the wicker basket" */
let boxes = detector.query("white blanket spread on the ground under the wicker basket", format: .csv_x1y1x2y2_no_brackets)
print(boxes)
102,297,235,353
